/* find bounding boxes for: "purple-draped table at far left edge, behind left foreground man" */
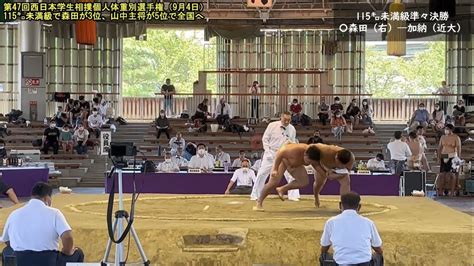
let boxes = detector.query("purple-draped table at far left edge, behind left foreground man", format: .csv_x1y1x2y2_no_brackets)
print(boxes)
0,167,49,197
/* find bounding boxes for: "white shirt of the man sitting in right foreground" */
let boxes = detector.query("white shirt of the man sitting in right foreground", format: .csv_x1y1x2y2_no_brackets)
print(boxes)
321,210,382,264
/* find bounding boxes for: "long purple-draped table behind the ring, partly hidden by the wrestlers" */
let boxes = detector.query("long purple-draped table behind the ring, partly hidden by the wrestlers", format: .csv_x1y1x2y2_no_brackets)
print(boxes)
105,173,400,196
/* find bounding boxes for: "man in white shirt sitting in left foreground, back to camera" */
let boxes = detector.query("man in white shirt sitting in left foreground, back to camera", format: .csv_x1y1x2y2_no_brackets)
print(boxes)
2,182,84,266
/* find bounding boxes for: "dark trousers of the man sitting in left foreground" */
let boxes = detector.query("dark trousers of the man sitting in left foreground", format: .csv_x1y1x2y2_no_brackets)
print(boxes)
2,246,84,266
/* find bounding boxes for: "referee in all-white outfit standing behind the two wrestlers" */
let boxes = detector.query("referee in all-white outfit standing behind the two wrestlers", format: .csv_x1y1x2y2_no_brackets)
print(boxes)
250,112,300,201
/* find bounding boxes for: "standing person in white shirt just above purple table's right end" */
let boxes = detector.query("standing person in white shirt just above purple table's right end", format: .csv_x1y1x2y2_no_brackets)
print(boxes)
387,131,412,176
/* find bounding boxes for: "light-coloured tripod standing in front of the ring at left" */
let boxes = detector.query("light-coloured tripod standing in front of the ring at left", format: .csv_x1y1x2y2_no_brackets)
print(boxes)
101,166,150,266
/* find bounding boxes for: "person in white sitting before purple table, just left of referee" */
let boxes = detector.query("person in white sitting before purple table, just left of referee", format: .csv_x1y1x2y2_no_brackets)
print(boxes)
225,159,256,195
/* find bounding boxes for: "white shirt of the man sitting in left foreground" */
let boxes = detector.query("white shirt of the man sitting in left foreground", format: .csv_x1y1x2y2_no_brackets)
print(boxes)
1,199,71,251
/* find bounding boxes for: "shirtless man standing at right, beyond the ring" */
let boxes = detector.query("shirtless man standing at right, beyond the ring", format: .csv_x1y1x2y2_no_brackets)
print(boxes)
436,124,461,197
